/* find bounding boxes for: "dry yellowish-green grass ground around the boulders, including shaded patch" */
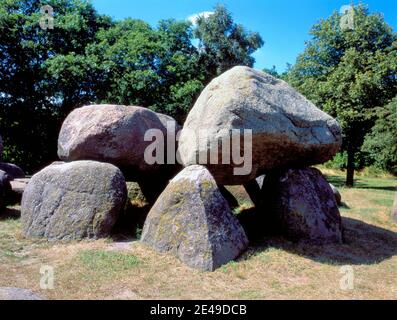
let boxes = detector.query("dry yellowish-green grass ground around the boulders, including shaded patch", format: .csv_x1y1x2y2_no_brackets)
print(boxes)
0,168,397,299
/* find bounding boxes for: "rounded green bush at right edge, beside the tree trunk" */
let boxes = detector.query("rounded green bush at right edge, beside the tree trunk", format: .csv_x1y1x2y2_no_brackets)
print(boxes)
363,97,397,175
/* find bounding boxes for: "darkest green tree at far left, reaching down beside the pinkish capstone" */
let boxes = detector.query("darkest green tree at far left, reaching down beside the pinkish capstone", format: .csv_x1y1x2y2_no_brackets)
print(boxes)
0,0,110,172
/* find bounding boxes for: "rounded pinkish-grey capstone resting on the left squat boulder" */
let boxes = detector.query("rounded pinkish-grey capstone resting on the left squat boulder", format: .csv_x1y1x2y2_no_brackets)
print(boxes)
58,105,180,178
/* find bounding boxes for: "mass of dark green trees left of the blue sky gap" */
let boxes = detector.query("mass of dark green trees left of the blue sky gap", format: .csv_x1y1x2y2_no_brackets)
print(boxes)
0,0,262,173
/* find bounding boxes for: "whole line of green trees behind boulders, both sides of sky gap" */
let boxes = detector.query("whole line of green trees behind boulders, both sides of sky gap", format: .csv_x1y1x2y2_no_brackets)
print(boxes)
0,0,397,185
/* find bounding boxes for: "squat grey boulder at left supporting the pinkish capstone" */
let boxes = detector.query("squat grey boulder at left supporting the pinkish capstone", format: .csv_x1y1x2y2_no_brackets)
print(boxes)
21,161,127,240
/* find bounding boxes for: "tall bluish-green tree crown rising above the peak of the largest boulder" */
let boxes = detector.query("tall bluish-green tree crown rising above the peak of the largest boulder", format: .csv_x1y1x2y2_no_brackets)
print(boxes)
194,5,264,81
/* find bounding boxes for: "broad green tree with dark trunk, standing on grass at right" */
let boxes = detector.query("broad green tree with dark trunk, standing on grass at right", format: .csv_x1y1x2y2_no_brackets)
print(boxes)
288,5,397,186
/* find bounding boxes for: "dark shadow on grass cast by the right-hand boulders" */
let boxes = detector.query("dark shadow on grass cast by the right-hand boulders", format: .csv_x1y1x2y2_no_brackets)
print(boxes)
239,209,397,265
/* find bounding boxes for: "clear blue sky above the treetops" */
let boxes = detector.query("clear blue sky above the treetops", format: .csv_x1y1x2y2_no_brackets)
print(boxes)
92,0,397,71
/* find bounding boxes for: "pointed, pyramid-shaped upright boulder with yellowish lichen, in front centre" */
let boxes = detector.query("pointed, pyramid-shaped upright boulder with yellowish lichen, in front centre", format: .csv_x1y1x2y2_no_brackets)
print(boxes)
142,166,248,271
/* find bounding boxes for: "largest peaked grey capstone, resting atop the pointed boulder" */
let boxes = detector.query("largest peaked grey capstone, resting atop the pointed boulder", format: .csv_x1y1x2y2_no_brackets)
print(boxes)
179,67,342,185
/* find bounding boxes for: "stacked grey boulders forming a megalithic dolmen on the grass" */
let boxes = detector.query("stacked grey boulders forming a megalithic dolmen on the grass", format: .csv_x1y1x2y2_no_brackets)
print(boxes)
13,67,343,271
